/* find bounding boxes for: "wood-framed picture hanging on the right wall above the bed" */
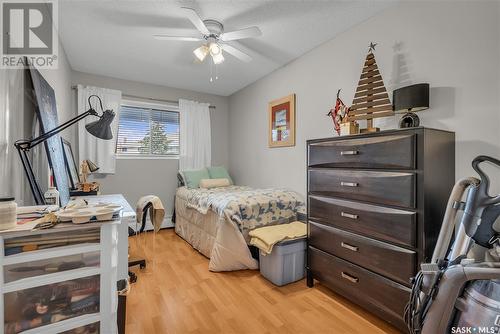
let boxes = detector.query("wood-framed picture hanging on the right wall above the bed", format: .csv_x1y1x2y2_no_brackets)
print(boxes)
268,94,295,147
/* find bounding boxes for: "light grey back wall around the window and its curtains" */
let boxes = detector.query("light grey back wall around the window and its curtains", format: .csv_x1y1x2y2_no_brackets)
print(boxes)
71,71,229,215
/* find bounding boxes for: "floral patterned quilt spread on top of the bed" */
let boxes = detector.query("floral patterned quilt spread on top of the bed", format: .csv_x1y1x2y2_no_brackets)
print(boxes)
186,186,305,231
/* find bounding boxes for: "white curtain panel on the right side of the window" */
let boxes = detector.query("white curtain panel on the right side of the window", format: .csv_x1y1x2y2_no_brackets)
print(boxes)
179,99,212,170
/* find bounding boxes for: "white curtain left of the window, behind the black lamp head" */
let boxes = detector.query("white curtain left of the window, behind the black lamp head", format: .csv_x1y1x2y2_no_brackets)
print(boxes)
77,85,122,174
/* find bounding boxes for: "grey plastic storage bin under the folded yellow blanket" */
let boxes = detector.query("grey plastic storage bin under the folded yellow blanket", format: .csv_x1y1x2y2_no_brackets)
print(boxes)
259,238,306,286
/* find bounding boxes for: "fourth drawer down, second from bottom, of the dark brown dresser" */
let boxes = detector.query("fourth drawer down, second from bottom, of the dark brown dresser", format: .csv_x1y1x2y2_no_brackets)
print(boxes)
309,222,416,285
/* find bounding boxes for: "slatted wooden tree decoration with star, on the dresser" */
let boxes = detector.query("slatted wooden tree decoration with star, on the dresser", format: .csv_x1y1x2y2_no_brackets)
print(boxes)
349,43,394,132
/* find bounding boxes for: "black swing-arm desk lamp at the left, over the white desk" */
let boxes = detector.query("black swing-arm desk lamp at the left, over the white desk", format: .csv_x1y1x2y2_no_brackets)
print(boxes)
14,95,115,205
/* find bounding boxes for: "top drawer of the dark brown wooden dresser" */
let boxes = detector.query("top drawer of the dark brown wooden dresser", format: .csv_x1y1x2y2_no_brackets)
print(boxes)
308,134,416,169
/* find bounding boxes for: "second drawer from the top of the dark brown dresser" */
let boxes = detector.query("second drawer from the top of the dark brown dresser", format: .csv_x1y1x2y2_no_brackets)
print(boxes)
309,169,415,208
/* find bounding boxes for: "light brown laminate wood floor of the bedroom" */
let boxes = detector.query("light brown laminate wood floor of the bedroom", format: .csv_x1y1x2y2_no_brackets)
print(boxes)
126,229,398,334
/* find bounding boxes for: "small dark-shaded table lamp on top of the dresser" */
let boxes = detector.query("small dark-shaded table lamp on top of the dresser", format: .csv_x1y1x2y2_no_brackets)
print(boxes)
392,83,429,128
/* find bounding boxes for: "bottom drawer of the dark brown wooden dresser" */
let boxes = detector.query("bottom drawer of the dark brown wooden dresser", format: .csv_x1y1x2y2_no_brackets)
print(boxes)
308,247,410,331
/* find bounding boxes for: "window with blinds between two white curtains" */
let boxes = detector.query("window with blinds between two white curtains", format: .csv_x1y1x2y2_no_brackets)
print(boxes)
116,103,179,157
